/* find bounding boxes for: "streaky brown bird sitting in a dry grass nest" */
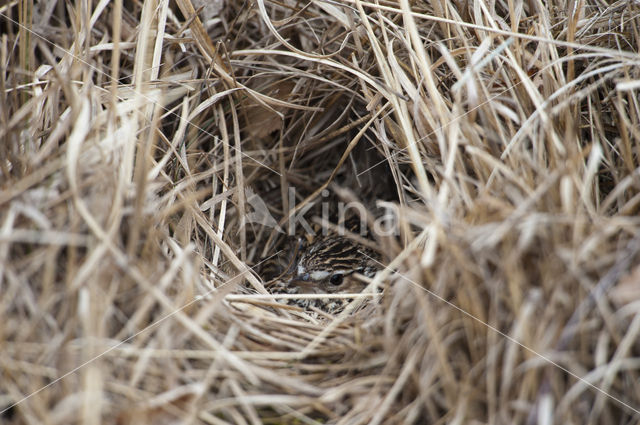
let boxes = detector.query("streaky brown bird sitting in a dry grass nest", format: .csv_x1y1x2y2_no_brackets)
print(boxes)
267,235,380,314
